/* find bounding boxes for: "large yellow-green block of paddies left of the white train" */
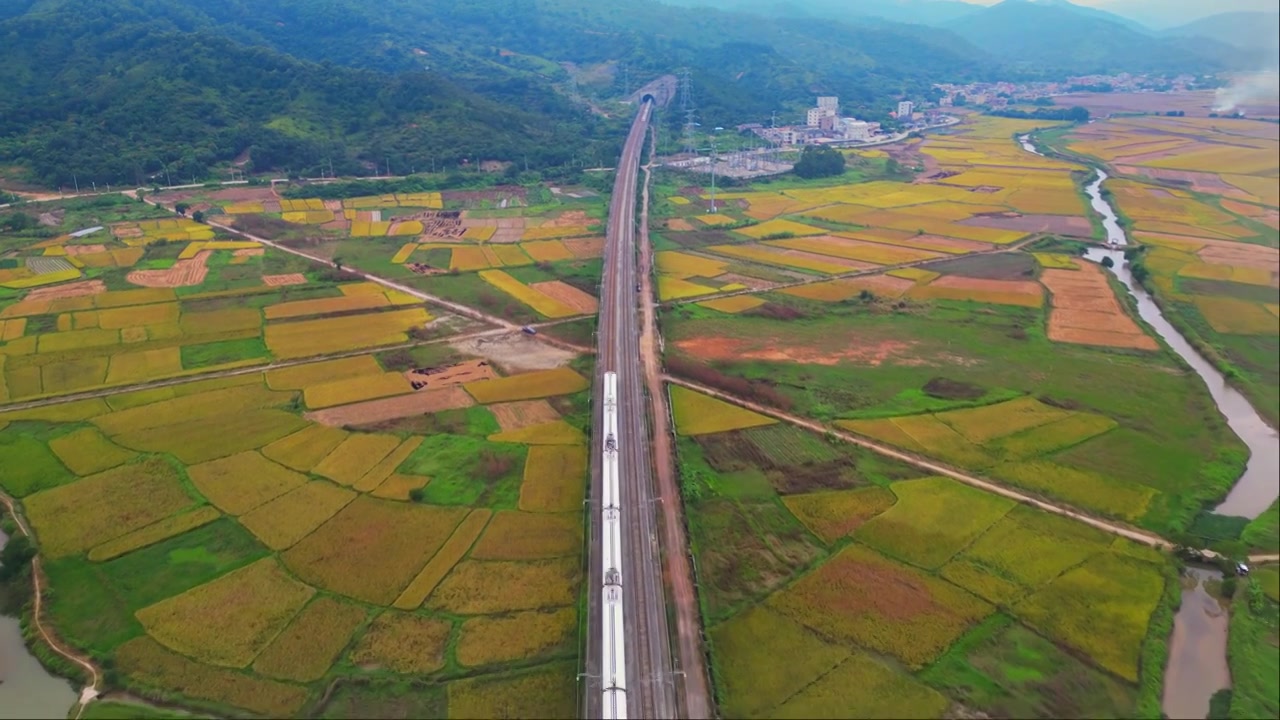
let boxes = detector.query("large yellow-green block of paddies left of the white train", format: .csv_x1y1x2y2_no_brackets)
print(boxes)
0,345,591,717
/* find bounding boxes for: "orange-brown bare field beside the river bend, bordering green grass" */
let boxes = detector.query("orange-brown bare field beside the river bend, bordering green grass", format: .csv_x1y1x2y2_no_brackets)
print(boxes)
1041,261,1160,350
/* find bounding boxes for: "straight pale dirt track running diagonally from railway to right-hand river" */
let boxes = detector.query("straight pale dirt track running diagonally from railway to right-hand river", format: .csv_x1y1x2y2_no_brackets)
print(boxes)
663,375,1280,562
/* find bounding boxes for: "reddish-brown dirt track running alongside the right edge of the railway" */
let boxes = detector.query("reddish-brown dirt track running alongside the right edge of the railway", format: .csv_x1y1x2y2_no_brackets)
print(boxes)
636,137,713,720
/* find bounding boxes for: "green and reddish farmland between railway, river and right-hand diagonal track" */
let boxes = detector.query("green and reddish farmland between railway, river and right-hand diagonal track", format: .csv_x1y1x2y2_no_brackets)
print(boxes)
662,260,1247,533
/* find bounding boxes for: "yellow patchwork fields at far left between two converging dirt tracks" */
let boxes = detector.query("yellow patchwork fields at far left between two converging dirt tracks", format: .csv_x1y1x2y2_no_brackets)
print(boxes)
0,199,476,402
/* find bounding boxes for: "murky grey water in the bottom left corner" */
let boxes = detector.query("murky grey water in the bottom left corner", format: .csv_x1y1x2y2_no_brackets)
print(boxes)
0,525,76,720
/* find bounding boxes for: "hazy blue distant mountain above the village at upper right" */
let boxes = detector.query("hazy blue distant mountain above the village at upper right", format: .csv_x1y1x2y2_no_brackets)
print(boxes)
947,0,1242,74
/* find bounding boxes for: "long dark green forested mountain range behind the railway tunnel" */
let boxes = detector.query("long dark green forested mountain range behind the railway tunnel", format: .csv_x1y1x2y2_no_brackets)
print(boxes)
0,0,1259,184
